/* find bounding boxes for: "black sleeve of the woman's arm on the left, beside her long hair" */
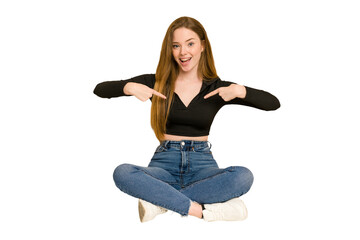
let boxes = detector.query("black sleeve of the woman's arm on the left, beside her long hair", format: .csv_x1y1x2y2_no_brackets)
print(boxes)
94,74,155,98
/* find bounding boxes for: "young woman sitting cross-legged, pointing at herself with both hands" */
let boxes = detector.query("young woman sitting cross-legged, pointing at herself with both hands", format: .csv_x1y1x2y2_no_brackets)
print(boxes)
94,17,280,222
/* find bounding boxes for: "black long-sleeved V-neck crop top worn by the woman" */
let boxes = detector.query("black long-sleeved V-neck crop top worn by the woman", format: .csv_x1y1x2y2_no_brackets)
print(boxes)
94,74,280,137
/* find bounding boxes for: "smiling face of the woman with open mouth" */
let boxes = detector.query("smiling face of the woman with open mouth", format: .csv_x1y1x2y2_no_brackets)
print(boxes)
172,27,204,72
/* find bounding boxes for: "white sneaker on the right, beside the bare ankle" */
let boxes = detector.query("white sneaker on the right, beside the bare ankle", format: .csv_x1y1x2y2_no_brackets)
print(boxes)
203,198,247,222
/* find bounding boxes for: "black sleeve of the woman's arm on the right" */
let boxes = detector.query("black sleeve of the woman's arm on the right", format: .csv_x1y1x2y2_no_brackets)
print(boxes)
223,81,280,111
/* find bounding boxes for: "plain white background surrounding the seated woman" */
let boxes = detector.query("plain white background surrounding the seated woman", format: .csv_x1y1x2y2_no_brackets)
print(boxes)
0,0,360,239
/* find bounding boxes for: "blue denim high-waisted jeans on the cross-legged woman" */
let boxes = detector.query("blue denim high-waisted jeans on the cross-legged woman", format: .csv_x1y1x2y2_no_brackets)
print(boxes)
114,140,253,216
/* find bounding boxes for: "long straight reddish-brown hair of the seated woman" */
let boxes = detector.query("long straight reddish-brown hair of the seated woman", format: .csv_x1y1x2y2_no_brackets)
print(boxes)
151,17,217,142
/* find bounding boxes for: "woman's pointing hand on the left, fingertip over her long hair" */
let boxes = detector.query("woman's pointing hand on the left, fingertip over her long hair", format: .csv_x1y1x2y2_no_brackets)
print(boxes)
124,82,166,102
